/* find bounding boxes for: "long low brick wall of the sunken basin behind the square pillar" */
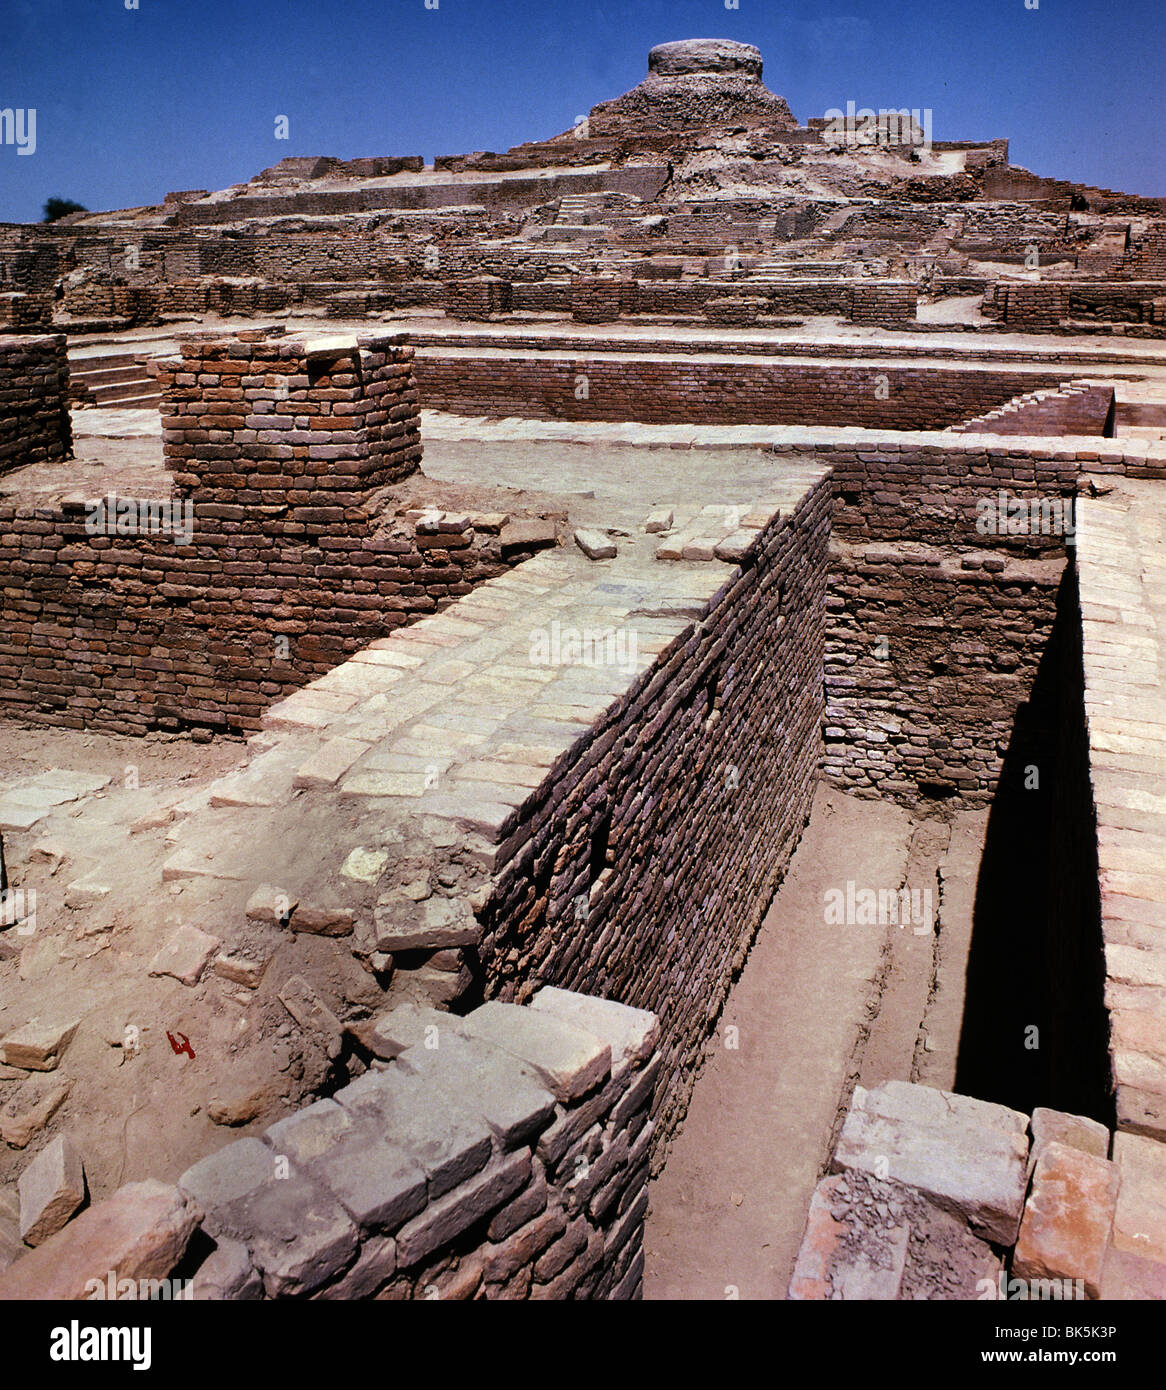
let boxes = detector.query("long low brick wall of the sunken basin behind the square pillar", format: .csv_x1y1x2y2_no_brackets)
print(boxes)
417,346,1063,430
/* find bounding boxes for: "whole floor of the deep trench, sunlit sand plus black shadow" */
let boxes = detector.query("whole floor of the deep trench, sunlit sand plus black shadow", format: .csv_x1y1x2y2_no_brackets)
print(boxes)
645,563,1113,1300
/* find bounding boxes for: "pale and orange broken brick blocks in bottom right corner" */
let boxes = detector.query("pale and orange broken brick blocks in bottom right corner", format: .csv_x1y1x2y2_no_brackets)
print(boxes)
788,1081,1166,1301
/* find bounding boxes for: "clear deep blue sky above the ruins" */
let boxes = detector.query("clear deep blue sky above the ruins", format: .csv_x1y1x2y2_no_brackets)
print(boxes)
0,0,1166,221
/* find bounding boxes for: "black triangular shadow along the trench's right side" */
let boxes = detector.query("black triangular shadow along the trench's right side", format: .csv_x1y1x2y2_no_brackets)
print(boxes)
955,563,1113,1126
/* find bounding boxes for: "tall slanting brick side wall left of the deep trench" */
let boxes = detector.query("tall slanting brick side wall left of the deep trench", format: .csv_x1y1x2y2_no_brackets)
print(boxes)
478,474,831,1163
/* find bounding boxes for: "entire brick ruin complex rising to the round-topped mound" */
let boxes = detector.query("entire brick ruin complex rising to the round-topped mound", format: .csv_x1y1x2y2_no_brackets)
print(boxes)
0,40,1166,1300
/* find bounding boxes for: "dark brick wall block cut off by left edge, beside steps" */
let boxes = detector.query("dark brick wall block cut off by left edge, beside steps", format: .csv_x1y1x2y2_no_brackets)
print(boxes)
0,334,72,474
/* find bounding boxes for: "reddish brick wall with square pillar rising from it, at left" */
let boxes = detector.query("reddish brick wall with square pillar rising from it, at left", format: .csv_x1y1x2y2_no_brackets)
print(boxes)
0,338,528,733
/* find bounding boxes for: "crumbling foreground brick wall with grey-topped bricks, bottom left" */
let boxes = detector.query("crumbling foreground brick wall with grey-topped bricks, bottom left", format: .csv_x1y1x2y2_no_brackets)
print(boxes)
0,990,659,1301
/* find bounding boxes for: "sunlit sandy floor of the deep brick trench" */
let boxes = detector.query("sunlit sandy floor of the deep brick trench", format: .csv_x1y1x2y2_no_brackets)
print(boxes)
643,787,987,1300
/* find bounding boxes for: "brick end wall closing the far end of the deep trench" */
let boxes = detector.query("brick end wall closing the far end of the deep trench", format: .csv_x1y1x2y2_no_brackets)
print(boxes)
775,439,1097,805
